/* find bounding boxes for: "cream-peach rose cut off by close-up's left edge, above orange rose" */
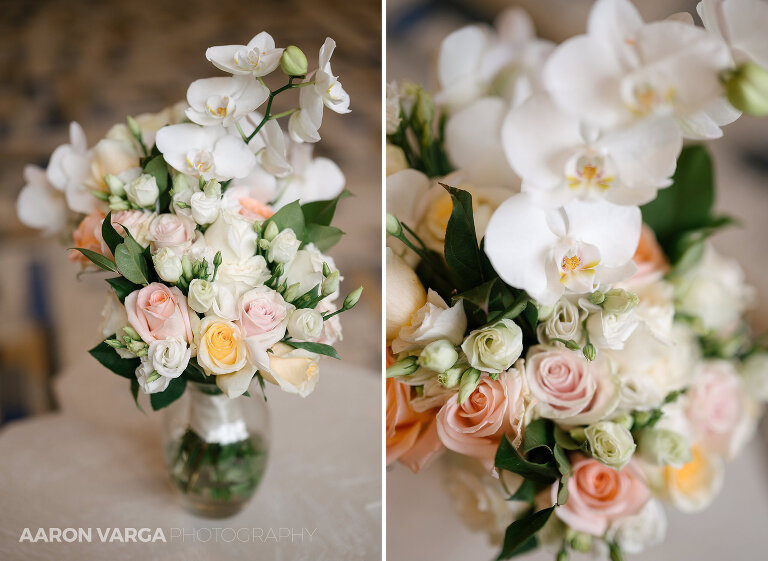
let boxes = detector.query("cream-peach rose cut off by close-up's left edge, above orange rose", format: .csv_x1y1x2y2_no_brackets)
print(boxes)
386,247,427,341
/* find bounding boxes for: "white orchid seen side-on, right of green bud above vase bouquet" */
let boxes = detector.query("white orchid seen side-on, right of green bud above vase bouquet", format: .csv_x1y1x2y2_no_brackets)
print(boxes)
288,37,350,142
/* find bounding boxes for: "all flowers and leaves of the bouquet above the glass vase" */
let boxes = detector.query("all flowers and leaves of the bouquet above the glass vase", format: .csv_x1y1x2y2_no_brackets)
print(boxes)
18,32,362,409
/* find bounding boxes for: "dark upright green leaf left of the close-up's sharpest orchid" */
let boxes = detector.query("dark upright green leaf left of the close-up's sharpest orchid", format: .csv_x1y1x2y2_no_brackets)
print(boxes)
440,183,485,290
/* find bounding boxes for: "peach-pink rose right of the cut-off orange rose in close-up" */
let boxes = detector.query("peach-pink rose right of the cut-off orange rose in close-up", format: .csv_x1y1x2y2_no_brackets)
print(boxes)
437,368,525,471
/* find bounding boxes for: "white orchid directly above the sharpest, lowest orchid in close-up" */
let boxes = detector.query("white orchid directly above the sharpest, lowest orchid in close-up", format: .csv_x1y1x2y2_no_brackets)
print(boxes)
501,94,682,206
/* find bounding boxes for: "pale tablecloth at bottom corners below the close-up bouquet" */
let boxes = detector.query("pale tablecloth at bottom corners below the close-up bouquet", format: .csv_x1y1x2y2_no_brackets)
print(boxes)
386,440,768,561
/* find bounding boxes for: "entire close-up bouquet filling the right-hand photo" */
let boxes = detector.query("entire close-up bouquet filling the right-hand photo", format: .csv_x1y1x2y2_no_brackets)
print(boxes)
386,0,768,561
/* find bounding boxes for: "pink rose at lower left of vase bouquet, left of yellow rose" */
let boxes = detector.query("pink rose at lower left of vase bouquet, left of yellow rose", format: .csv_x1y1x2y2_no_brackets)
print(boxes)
125,282,192,343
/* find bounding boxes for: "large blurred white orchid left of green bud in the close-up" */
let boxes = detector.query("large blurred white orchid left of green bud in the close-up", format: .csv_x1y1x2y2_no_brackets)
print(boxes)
544,0,739,138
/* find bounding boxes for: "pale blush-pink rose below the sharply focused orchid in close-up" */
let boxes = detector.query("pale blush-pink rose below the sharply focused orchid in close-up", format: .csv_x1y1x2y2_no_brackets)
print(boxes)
525,346,619,425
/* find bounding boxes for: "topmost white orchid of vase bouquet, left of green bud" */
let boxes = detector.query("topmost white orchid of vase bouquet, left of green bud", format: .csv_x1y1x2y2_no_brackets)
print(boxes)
205,31,283,77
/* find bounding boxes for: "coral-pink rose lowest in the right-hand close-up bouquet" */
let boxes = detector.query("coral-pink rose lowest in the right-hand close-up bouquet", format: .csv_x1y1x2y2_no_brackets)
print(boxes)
552,454,651,536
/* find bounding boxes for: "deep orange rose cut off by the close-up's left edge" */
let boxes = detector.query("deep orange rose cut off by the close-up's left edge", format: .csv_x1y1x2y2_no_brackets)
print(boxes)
386,378,443,473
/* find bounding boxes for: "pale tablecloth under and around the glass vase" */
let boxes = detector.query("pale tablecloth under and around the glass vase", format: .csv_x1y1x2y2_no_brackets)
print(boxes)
0,357,381,561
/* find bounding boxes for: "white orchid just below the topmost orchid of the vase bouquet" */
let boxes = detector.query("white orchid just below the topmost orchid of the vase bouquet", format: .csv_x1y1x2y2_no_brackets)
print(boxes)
185,76,269,127
